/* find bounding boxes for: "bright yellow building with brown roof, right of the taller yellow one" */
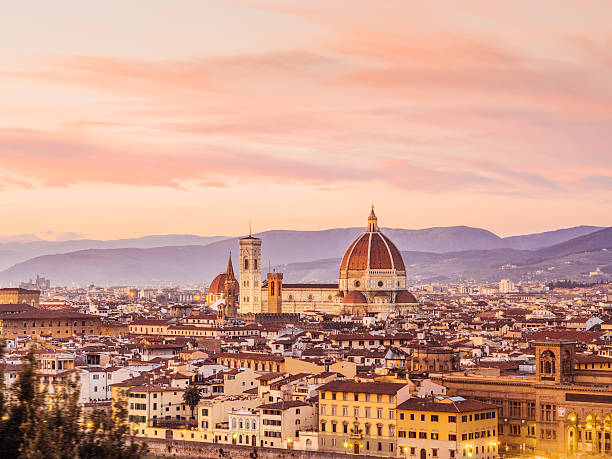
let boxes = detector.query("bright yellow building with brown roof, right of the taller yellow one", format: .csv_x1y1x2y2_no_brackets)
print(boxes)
397,397,498,459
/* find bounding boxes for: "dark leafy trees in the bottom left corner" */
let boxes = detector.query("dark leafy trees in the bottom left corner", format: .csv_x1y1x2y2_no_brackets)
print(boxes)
0,351,147,459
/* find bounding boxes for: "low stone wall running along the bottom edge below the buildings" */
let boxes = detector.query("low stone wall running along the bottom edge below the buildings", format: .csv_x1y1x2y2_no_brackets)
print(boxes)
137,439,384,459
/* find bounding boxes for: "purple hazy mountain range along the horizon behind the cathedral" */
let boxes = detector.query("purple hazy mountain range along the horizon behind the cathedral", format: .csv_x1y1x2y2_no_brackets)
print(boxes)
0,226,612,285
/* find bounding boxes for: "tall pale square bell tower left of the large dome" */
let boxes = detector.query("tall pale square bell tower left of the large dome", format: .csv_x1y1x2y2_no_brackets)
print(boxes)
239,234,262,314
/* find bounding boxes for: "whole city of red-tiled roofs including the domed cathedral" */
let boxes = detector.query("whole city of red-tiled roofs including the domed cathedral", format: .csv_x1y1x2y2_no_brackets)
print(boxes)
0,214,612,459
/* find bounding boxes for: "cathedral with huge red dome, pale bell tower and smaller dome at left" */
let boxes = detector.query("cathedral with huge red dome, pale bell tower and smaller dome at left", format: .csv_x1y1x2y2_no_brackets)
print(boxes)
208,207,419,316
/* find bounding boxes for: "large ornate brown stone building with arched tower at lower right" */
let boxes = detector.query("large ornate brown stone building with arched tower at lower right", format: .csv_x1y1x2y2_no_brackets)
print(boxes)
430,340,612,458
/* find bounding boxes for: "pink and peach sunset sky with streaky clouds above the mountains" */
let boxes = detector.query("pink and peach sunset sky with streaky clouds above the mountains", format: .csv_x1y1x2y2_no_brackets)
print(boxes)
0,0,612,239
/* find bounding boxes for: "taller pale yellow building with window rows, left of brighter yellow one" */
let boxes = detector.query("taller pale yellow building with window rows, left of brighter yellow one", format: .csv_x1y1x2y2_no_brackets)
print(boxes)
318,381,410,456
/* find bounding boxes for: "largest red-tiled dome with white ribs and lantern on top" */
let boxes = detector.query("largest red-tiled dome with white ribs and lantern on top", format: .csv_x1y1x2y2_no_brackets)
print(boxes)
340,208,406,272
